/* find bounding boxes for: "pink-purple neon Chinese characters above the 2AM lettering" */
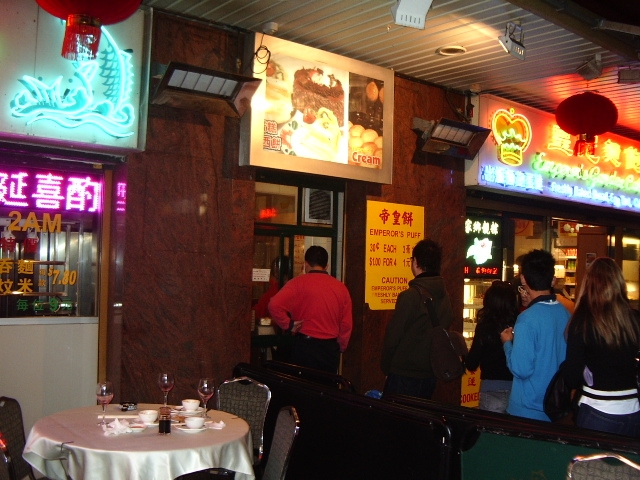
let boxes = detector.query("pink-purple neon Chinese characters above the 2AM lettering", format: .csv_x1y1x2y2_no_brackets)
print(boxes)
0,167,103,213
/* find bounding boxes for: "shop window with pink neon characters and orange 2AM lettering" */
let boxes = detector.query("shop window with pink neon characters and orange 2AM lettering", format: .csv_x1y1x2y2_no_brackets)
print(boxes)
0,164,103,318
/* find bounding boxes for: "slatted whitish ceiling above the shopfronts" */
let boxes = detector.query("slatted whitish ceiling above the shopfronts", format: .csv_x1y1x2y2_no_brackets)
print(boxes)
142,0,640,140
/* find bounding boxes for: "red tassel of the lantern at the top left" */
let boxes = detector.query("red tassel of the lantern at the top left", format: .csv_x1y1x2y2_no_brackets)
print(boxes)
62,15,100,62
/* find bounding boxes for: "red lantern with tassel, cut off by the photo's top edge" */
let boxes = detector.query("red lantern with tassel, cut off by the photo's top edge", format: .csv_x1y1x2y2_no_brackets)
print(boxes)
36,0,142,61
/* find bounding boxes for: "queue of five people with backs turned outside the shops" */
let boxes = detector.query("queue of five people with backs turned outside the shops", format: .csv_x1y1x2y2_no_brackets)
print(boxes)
268,239,640,437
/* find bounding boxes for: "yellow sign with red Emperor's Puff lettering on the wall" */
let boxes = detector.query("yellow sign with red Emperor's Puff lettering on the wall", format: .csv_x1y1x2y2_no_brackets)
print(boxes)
365,200,424,310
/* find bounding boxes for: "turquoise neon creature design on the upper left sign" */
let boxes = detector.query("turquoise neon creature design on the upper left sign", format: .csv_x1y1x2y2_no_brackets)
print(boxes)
11,28,135,138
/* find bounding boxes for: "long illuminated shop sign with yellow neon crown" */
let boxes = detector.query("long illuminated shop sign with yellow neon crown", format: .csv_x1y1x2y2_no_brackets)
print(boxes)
465,95,640,212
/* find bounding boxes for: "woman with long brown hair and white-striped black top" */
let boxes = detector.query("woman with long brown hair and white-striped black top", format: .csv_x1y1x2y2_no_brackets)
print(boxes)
560,257,640,437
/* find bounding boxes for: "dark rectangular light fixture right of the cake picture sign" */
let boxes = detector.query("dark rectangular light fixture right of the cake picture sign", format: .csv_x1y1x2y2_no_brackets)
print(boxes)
412,117,491,160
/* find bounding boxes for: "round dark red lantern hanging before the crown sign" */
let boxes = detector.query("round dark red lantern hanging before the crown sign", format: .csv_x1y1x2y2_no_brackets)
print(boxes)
556,92,618,156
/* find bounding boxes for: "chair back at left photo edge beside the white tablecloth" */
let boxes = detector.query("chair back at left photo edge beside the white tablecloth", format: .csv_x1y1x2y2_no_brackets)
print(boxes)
0,397,35,480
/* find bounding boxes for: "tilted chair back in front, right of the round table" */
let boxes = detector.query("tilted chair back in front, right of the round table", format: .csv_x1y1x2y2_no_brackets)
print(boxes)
261,406,300,480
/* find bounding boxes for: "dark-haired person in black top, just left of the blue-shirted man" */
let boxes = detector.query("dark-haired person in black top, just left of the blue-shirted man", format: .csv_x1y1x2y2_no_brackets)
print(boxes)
465,280,519,413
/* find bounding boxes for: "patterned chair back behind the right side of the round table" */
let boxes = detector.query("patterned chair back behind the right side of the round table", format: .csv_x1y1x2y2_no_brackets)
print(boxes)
216,377,271,465
